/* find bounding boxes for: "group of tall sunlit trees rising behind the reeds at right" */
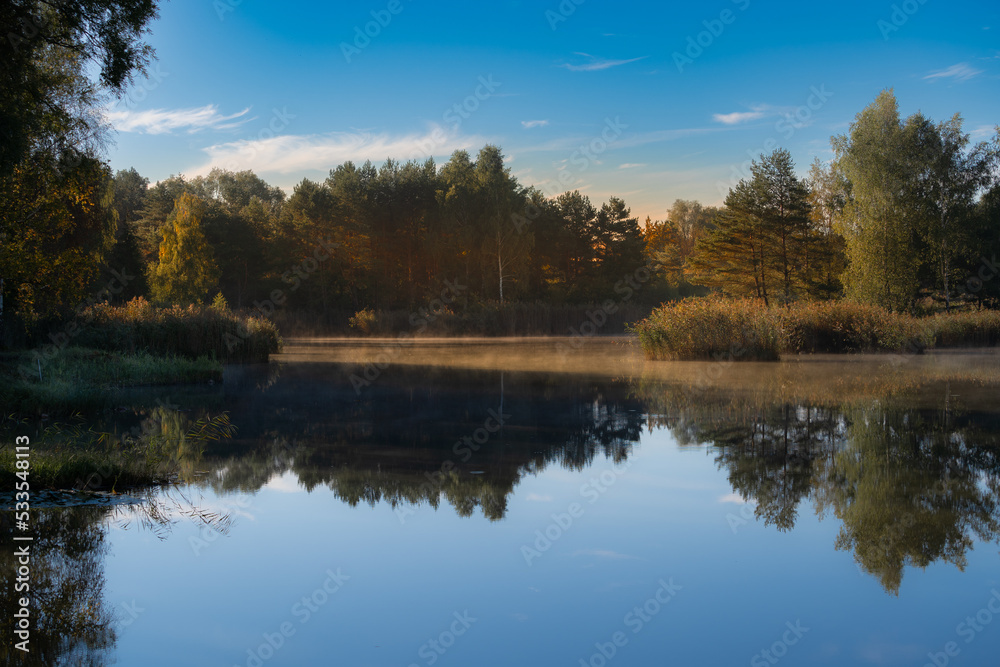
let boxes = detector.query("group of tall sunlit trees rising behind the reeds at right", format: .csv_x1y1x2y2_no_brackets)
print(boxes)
657,90,1000,311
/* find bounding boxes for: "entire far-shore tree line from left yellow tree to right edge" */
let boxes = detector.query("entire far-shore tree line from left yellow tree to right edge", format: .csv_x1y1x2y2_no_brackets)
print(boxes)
113,91,1000,320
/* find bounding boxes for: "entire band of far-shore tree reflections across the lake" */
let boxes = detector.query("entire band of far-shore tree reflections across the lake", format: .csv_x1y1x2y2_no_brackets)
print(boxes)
109,364,1000,592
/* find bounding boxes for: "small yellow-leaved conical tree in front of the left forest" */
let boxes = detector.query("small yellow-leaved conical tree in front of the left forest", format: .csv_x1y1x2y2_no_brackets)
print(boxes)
150,194,219,305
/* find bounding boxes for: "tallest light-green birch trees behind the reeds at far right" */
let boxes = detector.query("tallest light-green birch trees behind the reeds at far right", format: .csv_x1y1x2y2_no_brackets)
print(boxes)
833,90,998,310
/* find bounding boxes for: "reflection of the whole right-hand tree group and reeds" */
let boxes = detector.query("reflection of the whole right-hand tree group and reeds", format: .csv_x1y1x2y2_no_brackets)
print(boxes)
638,376,1000,593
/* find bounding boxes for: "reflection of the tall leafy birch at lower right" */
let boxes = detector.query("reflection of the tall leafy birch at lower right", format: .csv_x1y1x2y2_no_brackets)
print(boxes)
817,405,1000,592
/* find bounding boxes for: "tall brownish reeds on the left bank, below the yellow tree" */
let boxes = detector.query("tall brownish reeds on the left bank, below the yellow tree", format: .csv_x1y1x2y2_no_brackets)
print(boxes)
73,298,282,362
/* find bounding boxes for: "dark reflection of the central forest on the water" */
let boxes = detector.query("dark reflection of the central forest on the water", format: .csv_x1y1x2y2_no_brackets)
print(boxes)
206,365,643,520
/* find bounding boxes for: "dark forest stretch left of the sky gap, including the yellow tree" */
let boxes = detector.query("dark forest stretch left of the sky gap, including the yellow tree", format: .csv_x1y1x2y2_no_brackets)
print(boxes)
114,145,646,311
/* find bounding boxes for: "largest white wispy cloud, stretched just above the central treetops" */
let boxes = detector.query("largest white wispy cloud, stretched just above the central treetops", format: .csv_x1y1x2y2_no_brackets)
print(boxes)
186,125,488,176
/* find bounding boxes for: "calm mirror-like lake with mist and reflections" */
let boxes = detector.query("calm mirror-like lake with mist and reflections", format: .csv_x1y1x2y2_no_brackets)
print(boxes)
4,338,1000,667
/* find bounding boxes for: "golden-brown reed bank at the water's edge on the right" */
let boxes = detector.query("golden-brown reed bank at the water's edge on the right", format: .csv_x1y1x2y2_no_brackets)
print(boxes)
632,298,1000,361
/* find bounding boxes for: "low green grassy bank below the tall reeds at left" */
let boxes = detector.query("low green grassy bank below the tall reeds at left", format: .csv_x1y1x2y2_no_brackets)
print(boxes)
0,347,222,415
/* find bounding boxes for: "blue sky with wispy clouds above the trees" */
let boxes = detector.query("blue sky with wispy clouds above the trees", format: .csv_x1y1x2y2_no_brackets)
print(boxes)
108,0,1000,224
